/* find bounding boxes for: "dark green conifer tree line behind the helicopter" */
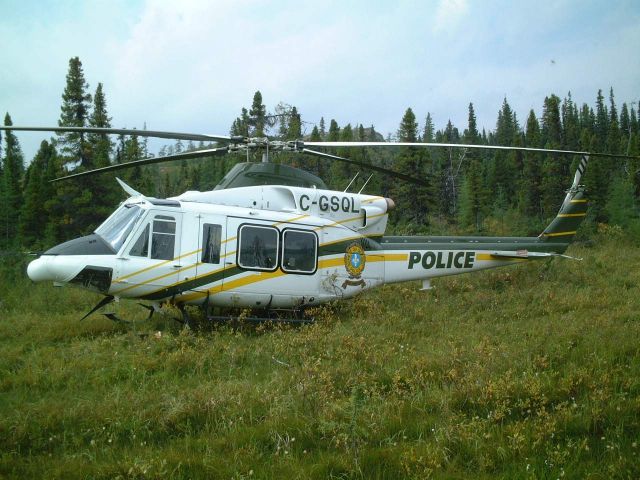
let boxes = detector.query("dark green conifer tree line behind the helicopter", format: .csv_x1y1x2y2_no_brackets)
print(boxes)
0,57,640,251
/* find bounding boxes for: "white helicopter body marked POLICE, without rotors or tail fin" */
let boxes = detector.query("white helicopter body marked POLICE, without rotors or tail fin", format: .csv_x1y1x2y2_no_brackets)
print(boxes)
28,186,586,309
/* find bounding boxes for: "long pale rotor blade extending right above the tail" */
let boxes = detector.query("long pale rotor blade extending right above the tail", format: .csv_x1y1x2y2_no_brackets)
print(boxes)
303,142,640,158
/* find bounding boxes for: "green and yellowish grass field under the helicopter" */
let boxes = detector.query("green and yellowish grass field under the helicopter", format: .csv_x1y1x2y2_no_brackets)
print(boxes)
0,232,640,480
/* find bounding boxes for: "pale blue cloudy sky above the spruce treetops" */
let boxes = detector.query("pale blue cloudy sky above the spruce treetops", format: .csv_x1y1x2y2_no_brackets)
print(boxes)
0,0,640,161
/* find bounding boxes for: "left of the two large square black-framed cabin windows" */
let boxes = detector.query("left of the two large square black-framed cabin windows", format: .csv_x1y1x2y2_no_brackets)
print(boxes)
238,225,279,271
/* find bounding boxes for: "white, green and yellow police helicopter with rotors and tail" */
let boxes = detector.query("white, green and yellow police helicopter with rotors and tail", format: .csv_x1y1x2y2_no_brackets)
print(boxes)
0,126,628,324
